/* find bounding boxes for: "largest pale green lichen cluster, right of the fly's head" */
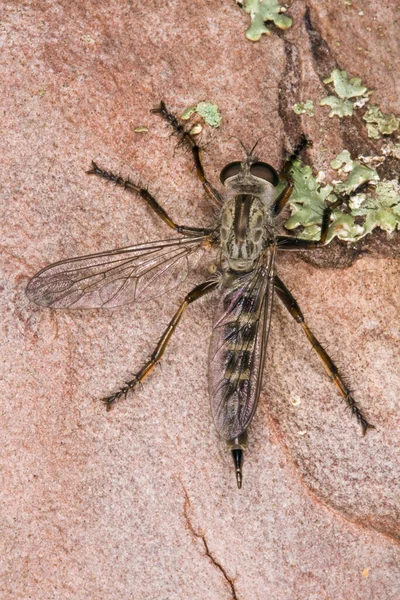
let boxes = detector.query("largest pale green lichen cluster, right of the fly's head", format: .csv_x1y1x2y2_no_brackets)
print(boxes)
285,150,400,242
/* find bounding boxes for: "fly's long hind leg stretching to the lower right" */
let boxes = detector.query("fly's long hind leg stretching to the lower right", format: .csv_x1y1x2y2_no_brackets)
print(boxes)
275,276,375,435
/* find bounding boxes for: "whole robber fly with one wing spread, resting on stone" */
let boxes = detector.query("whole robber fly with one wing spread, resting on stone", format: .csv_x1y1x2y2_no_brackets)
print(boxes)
27,102,373,488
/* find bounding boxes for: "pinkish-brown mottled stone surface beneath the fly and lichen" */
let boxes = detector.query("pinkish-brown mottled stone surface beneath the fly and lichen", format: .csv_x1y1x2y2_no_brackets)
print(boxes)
0,0,400,600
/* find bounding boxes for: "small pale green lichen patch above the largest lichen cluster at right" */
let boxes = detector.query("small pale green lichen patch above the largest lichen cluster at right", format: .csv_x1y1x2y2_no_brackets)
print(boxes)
320,69,370,118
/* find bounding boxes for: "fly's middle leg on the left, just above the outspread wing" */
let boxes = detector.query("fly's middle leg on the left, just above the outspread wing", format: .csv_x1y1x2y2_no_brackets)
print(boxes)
86,160,212,236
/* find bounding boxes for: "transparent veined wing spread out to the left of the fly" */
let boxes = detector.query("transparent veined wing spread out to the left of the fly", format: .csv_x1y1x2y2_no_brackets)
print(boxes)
26,236,210,308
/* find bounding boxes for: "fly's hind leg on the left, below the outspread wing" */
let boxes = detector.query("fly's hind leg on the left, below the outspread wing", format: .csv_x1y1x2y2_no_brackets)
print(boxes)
102,280,219,410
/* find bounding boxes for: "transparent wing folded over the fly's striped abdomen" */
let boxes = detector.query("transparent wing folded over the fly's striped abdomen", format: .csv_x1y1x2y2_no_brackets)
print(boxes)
209,255,274,440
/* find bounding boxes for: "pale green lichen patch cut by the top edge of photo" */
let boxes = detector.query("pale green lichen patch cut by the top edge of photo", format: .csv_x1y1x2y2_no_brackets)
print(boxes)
238,0,293,42
